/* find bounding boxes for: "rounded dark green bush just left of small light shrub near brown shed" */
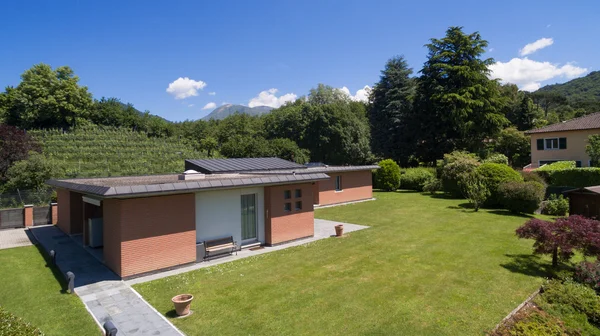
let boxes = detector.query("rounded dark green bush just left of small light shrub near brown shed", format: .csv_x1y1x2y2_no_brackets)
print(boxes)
498,182,546,214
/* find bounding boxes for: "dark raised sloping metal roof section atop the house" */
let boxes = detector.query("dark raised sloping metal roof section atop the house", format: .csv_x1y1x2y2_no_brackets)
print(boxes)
185,158,306,174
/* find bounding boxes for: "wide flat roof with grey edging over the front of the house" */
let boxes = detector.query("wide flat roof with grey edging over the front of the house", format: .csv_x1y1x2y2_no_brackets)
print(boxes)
46,171,329,198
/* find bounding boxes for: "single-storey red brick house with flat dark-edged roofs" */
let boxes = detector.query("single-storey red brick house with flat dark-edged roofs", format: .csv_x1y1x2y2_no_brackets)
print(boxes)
48,158,379,277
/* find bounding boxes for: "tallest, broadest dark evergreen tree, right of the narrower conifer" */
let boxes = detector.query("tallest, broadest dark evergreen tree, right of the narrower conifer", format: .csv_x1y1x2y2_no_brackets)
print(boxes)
417,27,508,161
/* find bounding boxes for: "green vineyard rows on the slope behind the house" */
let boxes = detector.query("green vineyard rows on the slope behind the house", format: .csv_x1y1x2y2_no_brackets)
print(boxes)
29,126,206,177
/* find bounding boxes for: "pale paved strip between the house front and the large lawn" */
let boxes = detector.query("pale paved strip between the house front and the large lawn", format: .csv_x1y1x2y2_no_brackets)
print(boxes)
126,218,368,285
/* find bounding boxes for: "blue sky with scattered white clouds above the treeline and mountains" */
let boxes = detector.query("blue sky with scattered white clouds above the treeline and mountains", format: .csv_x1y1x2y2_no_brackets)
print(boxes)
0,0,600,120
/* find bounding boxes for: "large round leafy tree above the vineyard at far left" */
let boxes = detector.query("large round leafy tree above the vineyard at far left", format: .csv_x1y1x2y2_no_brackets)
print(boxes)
0,63,93,129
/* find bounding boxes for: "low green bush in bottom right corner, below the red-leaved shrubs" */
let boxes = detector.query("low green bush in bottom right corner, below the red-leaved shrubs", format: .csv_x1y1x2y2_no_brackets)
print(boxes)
543,280,600,325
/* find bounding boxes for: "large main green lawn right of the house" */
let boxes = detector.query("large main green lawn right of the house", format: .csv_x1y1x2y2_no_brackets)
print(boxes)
135,192,548,335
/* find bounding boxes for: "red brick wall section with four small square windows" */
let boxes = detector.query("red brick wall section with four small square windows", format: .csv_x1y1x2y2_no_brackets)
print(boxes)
265,183,315,245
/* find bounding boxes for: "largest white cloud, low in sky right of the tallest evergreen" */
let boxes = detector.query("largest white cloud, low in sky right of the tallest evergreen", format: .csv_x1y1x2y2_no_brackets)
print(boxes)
490,57,588,91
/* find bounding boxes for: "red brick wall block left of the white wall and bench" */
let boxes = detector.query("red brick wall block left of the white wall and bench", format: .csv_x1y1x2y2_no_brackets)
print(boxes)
104,194,196,277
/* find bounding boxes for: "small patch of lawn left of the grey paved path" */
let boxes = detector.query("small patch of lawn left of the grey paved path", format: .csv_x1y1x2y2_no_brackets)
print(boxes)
0,246,100,336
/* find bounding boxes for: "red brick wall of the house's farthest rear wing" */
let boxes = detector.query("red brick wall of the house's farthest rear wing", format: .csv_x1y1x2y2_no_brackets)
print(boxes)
317,170,373,205
